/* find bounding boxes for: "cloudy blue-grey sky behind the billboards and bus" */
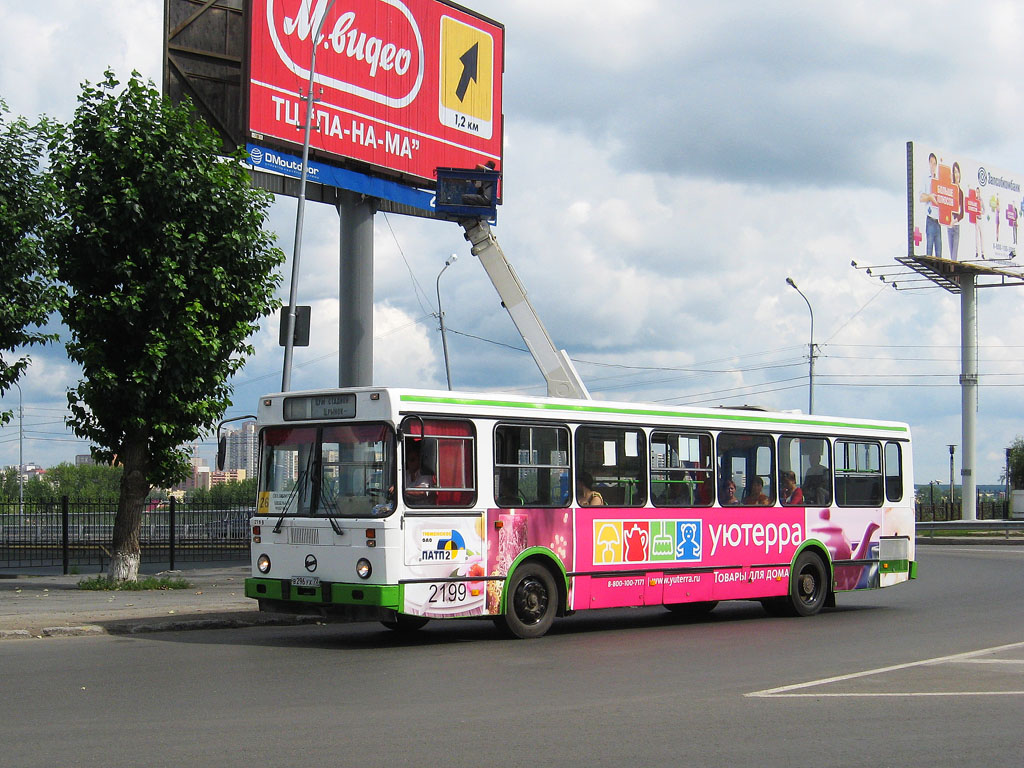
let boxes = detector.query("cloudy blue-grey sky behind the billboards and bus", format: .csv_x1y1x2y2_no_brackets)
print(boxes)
0,0,1024,483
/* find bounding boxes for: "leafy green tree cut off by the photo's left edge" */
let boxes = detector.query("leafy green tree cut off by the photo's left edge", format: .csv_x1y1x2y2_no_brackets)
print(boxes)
0,99,56,424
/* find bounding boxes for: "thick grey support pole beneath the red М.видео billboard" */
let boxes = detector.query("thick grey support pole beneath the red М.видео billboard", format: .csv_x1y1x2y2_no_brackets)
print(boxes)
338,189,374,387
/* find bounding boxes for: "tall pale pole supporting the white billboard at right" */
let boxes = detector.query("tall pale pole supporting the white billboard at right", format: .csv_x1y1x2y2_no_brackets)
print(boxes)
959,273,978,520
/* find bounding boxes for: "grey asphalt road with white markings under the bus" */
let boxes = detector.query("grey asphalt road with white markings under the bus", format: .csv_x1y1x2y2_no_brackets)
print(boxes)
0,545,1024,768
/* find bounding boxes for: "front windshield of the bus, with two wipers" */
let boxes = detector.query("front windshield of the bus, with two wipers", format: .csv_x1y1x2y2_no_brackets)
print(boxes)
259,424,395,517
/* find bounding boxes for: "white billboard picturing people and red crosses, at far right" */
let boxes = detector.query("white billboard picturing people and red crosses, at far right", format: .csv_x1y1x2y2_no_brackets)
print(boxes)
906,141,1024,261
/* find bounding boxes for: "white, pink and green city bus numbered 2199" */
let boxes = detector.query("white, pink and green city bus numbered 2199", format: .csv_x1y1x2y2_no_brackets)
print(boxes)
246,387,916,638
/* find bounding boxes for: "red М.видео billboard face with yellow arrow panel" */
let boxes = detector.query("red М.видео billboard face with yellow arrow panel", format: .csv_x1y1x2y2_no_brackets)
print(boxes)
248,0,505,184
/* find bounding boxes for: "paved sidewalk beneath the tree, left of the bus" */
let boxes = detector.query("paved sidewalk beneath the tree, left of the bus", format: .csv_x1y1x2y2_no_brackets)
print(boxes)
0,564,315,641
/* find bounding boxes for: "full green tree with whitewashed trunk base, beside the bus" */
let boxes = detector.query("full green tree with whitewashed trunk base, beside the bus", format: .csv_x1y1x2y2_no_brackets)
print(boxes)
47,71,284,581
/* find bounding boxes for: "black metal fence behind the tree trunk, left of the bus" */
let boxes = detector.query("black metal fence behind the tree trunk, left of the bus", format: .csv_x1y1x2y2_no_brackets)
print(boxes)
0,497,256,573
